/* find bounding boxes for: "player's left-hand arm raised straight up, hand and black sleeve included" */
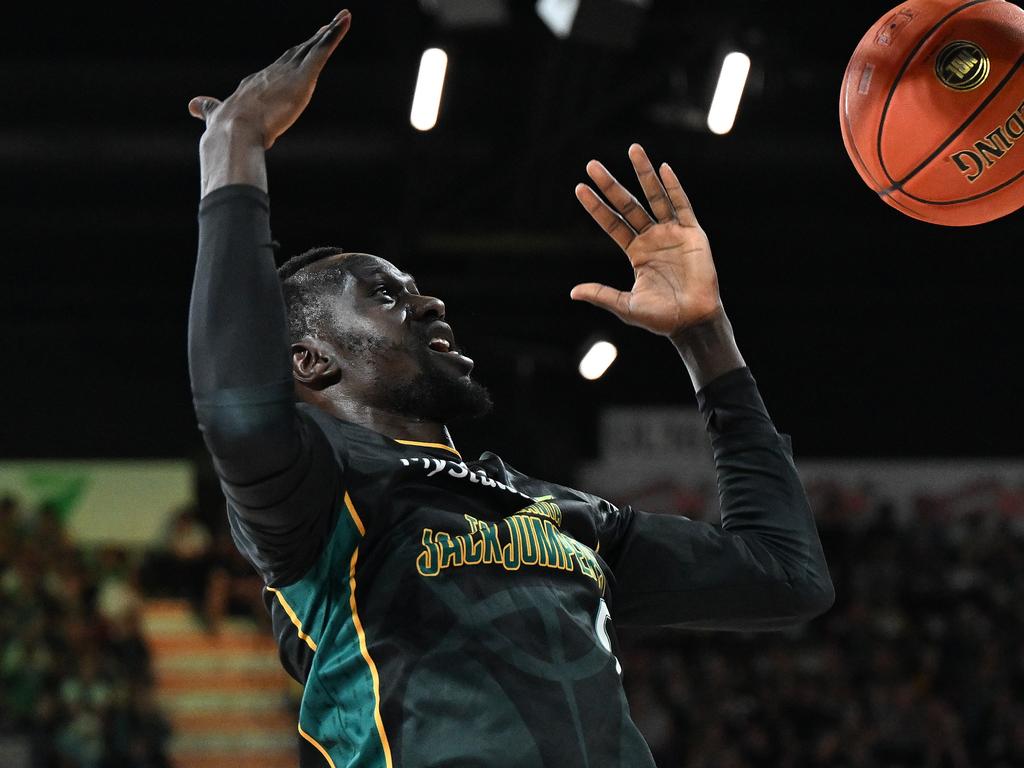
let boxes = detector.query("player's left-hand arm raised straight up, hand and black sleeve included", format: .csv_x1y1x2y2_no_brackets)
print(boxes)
188,11,350,584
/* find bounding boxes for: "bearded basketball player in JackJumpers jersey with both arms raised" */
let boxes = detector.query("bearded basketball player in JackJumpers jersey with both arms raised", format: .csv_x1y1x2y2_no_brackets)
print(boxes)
188,11,834,768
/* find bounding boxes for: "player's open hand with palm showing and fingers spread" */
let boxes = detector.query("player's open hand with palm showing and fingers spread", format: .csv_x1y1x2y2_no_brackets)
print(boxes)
570,144,722,337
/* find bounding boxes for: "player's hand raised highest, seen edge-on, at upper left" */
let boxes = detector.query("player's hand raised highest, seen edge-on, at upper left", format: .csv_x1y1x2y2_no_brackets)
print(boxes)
188,10,352,150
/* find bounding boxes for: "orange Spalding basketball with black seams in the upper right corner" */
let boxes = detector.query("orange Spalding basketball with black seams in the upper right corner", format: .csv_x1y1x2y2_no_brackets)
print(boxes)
839,0,1024,226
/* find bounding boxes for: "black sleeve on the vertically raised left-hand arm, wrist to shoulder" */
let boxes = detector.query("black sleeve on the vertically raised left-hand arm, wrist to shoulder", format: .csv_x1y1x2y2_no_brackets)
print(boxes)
188,184,340,584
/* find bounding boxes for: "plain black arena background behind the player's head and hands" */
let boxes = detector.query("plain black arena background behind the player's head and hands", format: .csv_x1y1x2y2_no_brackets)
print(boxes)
0,0,1024,479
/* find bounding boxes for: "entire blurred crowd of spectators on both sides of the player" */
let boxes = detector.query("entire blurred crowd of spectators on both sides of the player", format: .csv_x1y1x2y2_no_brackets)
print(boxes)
6,475,1024,768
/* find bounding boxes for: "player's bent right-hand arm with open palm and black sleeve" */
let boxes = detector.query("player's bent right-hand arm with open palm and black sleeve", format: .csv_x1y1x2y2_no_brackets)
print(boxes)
571,144,835,629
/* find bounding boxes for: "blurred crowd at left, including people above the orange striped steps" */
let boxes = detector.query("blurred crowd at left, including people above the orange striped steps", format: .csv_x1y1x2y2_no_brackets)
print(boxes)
0,495,269,768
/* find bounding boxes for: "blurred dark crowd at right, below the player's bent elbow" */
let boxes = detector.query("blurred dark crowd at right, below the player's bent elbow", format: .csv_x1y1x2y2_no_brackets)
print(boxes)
620,487,1024,768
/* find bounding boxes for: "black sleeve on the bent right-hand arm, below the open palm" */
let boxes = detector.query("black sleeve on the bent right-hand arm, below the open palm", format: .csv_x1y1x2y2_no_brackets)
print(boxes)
609,368,834,629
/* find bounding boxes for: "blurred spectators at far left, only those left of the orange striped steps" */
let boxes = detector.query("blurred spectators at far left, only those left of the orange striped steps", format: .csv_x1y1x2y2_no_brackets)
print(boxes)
0,497,170,768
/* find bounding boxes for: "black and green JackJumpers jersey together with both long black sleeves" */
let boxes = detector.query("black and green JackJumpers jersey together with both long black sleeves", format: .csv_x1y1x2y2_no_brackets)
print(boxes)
189,185,833,768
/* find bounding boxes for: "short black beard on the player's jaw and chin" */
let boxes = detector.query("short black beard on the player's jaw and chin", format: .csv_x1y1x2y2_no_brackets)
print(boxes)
339,335,494,424
